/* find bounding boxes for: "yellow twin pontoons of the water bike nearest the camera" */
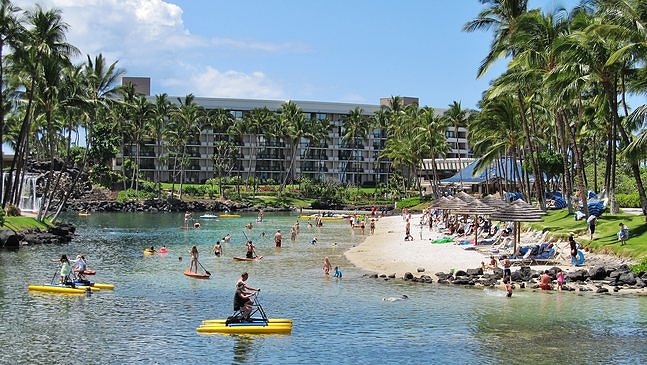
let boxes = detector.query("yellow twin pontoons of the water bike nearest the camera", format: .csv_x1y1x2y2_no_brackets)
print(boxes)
196,318,292,334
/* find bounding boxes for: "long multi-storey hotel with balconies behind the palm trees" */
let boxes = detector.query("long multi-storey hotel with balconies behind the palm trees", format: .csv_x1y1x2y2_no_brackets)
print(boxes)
114,78,471,185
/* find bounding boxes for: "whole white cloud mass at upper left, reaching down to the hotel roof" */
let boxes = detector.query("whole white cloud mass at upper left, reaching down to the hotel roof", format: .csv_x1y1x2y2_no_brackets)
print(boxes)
13,0,286,98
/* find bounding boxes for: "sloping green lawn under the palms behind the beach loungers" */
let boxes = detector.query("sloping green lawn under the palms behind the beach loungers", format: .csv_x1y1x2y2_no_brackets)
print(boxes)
528,209,647,262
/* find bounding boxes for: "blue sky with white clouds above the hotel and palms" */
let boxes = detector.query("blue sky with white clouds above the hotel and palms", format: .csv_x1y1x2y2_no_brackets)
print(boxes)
13,0,647,108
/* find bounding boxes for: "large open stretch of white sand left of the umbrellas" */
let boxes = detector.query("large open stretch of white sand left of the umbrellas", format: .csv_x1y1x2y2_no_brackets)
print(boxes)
345,215,486,279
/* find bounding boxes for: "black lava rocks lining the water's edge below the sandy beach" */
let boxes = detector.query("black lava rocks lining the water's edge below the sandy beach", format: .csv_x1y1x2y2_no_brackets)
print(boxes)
365,264,647,295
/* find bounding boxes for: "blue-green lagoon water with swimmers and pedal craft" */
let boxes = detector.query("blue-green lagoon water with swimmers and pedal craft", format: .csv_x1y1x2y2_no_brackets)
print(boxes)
0,213,647,364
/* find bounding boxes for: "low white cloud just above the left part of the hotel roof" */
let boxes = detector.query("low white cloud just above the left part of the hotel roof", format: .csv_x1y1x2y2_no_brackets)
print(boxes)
163,67,283,99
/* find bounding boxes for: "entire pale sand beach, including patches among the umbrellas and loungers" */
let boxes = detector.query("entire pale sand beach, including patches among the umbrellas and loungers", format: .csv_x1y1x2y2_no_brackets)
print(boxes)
345,214,634,280
